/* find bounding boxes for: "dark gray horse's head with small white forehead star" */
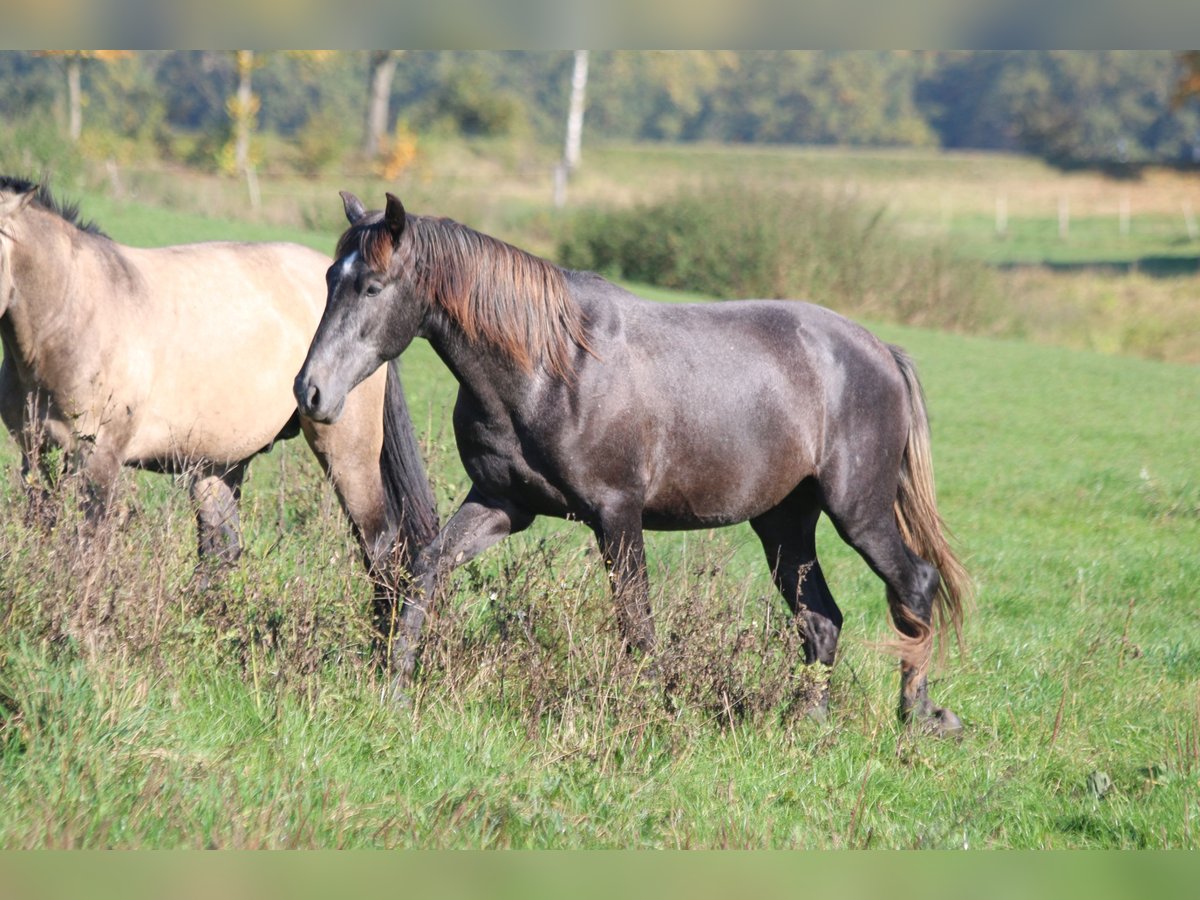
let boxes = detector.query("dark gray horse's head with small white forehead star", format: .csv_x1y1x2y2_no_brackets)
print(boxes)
293,191,427,422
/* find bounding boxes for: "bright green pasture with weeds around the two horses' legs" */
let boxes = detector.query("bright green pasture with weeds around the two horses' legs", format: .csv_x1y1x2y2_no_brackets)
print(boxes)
0,187,1200,848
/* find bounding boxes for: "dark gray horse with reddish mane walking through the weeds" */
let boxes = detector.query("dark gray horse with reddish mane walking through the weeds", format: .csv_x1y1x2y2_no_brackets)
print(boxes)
295,193,970,733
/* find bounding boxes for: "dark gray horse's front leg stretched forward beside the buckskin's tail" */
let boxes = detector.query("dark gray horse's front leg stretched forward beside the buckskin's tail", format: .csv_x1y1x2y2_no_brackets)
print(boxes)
378,487,534,701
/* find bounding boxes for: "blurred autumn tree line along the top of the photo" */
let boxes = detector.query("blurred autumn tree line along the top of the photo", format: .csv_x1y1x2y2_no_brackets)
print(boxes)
7,50,1200,166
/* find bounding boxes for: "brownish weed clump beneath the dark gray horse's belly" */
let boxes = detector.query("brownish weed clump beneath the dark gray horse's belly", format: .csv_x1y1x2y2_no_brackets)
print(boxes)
416,539,827,744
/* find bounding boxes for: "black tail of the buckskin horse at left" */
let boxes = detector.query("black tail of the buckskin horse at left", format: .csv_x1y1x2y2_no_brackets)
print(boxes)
379,362,438,569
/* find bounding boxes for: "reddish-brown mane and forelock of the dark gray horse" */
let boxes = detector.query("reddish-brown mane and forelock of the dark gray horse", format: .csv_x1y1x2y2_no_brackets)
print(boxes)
337,216,590,379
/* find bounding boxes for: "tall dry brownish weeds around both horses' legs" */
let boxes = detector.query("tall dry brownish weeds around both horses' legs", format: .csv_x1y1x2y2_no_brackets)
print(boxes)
0,420,840,758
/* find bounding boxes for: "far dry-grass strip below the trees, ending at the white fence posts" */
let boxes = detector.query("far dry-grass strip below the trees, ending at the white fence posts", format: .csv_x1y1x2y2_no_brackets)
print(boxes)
75,139,1200,262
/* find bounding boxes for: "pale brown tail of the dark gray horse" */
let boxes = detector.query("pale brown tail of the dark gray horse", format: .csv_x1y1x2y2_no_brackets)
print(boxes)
888,346,972,671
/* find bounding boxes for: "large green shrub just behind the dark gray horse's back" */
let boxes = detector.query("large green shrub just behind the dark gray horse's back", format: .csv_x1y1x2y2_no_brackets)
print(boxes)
558,184,1000,329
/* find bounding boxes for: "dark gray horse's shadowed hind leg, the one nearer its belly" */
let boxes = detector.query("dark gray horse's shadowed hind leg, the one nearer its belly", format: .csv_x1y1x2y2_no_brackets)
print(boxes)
750,493,842,718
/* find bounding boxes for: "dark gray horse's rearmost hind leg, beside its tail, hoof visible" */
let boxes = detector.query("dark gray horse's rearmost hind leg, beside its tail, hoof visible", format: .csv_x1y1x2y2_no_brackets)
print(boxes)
830,503,962,736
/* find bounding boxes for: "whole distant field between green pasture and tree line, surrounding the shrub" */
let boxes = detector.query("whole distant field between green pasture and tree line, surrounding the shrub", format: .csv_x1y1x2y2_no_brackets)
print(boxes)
59,139,1200,364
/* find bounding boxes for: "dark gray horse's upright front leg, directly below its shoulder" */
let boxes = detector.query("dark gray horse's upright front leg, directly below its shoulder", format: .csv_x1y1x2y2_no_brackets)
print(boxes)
595,504,654,654
